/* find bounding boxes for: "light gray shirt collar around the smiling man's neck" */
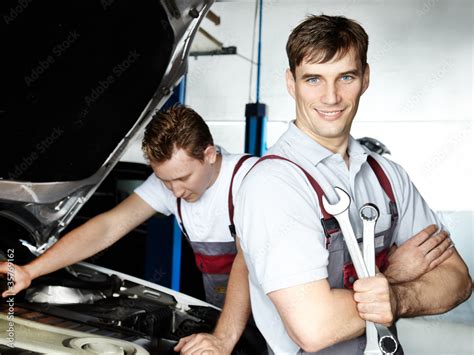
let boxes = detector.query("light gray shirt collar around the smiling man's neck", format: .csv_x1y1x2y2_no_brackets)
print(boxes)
285,121,367,166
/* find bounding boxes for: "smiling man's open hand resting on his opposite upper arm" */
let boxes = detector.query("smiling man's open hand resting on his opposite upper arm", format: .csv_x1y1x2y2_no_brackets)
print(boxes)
384,224,454,284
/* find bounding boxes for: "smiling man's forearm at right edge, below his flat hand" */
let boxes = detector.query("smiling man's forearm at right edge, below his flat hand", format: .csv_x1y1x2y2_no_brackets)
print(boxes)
392,253,472,317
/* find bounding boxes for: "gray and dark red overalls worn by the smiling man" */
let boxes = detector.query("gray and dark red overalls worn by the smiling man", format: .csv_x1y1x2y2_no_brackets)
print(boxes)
254,155,403,355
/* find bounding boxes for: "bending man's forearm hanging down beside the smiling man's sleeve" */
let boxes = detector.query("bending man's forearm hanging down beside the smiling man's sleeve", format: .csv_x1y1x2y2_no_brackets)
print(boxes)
213,253,251,351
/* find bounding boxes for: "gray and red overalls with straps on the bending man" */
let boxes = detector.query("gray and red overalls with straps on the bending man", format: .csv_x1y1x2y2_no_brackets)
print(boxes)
176,155,252,308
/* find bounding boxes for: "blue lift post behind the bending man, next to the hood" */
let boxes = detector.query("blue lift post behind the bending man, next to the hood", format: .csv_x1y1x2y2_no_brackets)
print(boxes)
145,76,186,291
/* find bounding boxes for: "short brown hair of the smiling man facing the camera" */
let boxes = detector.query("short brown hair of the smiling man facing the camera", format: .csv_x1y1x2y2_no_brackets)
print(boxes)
286,15,369,76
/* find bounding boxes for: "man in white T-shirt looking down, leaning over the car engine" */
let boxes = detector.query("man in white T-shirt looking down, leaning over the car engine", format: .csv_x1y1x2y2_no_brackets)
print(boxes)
0,106,256,307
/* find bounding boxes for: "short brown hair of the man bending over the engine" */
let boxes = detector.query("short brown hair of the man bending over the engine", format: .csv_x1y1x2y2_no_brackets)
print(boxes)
142,105,214,163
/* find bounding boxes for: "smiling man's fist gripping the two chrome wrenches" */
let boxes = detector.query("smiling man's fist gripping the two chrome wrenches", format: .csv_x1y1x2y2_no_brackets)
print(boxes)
354,273,397,327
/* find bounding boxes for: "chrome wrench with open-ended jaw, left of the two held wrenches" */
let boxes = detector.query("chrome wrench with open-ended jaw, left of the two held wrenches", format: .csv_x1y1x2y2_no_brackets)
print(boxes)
323,187,398,354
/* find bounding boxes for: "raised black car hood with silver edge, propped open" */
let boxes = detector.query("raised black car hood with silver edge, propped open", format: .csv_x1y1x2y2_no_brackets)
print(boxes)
0,0,213,254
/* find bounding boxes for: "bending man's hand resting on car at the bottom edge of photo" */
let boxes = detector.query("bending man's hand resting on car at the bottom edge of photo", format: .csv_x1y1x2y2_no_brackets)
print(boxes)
174,333,232,355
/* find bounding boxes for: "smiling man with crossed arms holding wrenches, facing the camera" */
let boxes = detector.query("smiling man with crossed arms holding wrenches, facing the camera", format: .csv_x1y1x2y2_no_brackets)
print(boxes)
177,15,471,355
